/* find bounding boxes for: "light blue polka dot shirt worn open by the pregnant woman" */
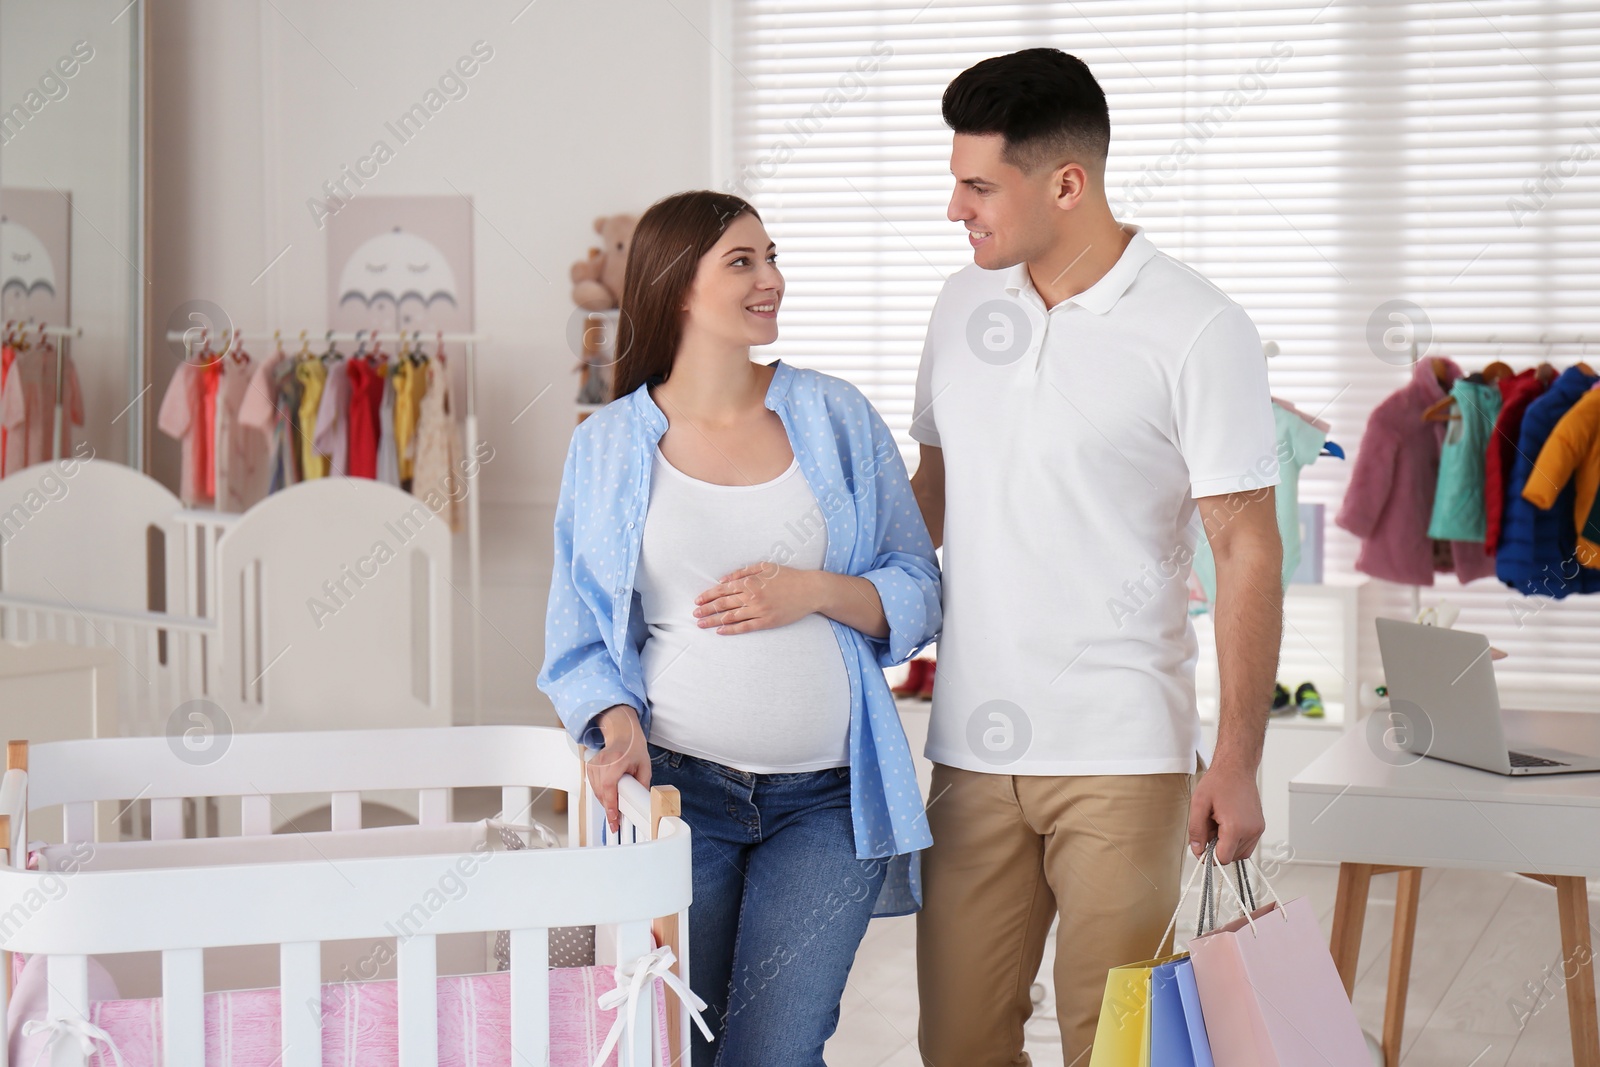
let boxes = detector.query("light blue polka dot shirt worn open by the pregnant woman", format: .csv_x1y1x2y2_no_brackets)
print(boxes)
538,362,942,915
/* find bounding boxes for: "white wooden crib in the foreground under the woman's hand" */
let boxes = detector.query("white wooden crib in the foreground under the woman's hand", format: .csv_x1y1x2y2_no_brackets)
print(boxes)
0,726,691,1067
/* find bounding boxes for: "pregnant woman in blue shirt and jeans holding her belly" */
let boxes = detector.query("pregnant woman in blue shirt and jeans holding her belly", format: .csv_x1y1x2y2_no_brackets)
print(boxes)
539,192,941,1067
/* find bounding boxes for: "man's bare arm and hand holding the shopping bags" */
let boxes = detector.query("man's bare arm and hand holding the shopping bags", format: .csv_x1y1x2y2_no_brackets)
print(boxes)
1189,486,1283,864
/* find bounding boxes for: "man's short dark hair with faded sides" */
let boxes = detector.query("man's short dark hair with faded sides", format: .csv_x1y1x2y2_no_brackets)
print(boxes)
942,48,1110,174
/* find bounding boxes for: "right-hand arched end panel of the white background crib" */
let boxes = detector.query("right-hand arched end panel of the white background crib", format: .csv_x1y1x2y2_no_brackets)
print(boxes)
211,478,454,731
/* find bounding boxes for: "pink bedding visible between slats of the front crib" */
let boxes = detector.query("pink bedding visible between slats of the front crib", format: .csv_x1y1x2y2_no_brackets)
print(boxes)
10,957,670,1067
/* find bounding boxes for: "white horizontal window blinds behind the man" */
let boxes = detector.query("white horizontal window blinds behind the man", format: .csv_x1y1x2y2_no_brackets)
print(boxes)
732,0,1600,709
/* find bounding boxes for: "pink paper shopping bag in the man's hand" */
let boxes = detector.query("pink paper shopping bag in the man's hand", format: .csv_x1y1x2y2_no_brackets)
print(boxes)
1189,865,1373,1067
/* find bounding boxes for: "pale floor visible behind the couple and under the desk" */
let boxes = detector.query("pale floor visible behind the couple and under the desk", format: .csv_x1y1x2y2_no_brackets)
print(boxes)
827,701,1600,1067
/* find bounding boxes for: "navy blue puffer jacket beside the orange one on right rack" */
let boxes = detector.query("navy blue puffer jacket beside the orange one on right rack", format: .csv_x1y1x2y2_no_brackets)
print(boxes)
1494,365,1600,600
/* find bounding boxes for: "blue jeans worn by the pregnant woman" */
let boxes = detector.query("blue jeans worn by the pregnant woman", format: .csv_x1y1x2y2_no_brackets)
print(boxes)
650,745,888,1067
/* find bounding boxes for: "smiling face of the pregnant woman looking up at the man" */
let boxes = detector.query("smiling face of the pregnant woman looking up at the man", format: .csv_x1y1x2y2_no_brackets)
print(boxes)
685,214,784,346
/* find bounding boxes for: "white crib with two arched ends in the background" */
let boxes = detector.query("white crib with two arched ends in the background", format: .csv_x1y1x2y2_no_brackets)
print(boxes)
0,459,454,829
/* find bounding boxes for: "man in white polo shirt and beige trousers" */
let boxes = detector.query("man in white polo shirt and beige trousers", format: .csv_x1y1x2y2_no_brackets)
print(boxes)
910,48,1283,1067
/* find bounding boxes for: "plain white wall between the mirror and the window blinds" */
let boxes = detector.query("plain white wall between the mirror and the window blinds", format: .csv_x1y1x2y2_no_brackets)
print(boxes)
149,0,722,718
